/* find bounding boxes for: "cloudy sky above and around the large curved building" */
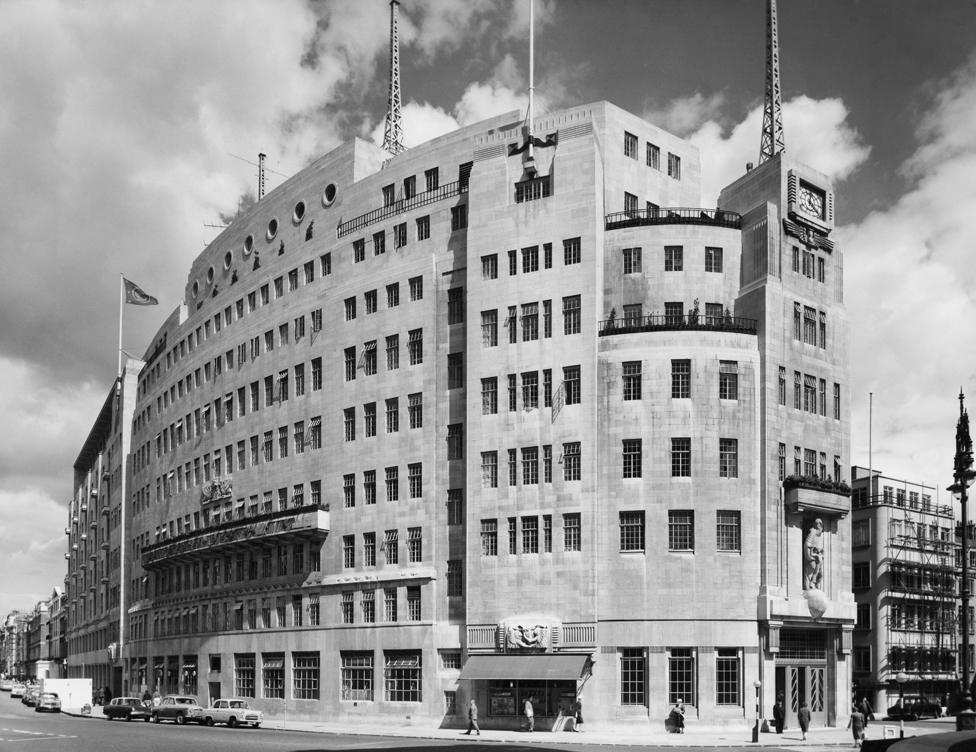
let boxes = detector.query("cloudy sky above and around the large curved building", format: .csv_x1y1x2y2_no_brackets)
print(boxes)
0,0,976,614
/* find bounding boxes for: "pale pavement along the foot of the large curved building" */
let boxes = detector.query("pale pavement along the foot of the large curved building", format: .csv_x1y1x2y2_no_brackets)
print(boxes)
62,706,956,752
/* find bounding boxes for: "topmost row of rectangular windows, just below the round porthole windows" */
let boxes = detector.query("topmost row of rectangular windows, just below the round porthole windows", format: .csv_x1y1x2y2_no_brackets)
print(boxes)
139,253,332,397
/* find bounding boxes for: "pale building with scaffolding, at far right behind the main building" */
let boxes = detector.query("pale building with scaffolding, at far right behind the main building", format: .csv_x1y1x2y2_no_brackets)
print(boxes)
851,466,958,712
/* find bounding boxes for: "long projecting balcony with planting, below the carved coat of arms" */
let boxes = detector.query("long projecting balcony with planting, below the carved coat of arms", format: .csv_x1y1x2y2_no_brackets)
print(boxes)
142,507,330,569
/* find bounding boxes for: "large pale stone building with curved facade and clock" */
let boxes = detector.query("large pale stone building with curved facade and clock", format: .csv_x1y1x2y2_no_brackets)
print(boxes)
123,103,854,727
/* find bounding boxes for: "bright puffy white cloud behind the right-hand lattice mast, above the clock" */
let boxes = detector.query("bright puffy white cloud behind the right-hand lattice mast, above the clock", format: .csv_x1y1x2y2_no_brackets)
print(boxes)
677,96,871,206
